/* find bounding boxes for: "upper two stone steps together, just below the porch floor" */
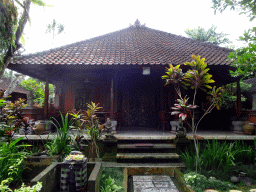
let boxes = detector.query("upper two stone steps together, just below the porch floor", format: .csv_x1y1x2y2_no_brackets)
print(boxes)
116,140,180,163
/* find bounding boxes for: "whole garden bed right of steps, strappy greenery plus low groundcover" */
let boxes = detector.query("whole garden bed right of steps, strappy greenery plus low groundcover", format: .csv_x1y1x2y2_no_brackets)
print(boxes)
181,140,256,192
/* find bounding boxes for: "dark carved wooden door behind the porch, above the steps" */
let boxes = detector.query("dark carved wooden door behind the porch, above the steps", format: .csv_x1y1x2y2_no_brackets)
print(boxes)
122,77,157,127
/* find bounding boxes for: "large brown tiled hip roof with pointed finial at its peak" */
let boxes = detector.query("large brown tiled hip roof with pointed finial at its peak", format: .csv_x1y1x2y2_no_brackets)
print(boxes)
11,22,232,65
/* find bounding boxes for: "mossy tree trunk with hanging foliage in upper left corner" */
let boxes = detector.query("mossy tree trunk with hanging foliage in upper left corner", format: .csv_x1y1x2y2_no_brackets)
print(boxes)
0,0,45,77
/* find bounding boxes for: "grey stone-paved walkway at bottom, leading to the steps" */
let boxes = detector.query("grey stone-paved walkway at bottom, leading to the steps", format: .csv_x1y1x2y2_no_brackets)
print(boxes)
133,175,179,192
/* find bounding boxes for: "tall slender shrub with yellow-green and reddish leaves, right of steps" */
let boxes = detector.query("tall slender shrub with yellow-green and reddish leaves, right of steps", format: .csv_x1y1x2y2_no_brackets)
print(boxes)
162,55,221,170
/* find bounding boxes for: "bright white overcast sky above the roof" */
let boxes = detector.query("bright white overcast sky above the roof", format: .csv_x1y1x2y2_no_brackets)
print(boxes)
24,0,255,54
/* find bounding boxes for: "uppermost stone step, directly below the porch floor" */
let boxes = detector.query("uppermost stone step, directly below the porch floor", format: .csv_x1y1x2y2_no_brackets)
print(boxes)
117,143,176,149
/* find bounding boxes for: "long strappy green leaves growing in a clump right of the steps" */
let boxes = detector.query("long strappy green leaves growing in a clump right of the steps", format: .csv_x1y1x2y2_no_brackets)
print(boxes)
181,140,256,173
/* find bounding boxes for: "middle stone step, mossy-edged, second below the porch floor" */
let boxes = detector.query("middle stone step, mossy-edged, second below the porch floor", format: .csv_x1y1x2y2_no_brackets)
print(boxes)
116,153,180,160
